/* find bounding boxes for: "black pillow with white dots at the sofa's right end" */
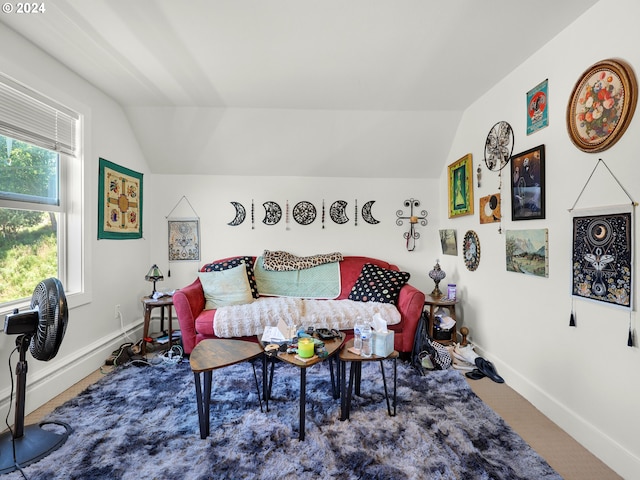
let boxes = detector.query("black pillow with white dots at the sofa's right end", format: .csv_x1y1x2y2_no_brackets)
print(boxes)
349,263,411,305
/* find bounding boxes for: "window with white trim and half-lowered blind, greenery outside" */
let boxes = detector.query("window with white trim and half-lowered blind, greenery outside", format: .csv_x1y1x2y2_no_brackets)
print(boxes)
0,74,83,314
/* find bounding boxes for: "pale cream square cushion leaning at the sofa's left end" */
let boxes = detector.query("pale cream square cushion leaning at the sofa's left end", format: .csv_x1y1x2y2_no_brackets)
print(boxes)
198,264,254,310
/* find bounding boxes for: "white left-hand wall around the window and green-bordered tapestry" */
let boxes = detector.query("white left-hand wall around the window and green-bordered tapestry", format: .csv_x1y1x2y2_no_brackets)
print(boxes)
0,26,150,418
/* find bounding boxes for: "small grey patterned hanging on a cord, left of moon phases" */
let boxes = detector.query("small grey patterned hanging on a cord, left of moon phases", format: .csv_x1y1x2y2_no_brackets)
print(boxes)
165,195,200,262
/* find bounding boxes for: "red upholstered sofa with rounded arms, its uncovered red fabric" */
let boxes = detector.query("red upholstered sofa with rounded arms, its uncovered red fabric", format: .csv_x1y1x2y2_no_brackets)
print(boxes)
173,256,425,354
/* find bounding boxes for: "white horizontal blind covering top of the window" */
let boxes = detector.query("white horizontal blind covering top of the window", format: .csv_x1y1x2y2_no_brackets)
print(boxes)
0,74,79,156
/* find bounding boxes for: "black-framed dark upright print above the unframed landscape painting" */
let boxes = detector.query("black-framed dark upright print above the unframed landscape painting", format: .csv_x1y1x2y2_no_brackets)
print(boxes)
511,145,545,220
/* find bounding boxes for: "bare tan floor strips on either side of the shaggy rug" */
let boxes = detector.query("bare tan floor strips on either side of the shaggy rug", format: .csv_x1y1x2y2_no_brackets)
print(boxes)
18,367,622,480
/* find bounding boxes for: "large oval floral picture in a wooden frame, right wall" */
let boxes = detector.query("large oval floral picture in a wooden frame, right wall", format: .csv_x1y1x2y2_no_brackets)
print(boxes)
567,59,638,152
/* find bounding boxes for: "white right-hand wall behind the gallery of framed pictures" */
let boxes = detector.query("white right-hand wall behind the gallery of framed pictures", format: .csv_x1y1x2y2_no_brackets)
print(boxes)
439,0,640,479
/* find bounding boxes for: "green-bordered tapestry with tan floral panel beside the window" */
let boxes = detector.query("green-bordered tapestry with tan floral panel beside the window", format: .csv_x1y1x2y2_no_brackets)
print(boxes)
98,158,142,240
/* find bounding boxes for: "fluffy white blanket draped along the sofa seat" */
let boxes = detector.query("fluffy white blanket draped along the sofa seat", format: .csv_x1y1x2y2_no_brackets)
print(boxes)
218,297,400,338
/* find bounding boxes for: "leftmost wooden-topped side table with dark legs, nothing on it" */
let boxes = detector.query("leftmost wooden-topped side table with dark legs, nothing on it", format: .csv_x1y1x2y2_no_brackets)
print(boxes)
189,338,266,438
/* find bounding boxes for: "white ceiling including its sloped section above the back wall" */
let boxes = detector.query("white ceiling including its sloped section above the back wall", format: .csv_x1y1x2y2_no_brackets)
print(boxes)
0,0,597,178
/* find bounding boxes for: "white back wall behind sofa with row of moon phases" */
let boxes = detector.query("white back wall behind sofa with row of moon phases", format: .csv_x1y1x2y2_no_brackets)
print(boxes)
150,175,440,291
